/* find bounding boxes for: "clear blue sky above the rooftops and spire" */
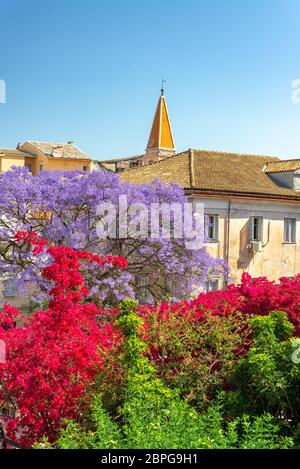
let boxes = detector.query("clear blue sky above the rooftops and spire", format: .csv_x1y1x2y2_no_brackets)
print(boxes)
0,0,300,159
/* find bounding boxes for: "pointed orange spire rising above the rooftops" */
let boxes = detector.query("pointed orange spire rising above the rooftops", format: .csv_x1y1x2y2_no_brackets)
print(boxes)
144,89,176,163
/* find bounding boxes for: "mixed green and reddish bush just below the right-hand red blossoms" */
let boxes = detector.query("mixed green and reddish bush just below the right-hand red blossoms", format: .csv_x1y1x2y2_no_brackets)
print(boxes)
147,311,249,411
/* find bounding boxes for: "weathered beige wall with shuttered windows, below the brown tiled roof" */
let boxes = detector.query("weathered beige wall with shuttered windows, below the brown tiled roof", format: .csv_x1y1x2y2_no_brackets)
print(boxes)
194,196,300,288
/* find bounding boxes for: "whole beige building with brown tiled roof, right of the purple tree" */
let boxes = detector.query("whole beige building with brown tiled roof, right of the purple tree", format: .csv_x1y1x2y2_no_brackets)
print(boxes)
120,149,300,289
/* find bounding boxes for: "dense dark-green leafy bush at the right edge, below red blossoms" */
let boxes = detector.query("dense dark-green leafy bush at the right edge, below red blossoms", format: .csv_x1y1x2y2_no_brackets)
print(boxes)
227,311,300,426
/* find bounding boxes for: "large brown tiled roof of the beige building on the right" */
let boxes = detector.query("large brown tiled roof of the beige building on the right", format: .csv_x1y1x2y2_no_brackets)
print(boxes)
120,150,300,199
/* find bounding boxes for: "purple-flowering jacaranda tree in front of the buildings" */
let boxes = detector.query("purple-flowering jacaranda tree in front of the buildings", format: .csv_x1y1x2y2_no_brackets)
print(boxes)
0,168,225,305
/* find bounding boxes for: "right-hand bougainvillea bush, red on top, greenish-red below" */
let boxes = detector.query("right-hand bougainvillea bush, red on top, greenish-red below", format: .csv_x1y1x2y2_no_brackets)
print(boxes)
139,274,300,415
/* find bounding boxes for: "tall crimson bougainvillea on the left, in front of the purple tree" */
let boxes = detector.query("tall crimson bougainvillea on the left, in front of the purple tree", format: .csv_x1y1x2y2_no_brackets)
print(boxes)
0,232,127,445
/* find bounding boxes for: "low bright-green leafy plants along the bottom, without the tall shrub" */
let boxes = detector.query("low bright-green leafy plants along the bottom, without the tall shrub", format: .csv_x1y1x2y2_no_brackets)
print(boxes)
56,396,293,449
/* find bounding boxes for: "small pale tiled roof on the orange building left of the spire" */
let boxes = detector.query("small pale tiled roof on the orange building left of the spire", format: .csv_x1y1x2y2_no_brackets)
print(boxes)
25,140,91,160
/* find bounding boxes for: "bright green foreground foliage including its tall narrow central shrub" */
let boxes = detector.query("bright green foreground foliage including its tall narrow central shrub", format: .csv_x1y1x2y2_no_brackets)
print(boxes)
57,300,292,449
